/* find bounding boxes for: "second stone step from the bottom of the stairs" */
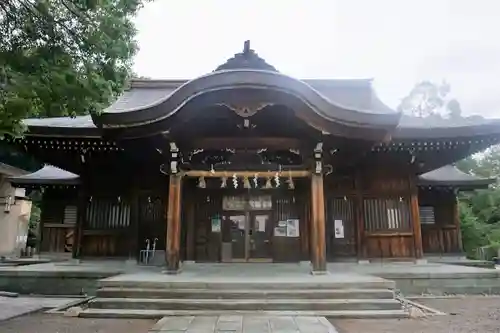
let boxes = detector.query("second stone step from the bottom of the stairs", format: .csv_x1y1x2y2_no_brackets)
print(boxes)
88,298,401,311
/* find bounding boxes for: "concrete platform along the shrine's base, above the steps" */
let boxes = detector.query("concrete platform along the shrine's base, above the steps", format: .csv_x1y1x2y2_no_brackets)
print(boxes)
0,260,500,295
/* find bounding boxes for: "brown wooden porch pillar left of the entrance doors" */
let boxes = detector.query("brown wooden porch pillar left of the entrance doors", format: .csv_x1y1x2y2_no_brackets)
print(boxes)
166,174,182,274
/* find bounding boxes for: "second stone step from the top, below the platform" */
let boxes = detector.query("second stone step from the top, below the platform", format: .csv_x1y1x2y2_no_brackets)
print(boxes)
96,287,394,299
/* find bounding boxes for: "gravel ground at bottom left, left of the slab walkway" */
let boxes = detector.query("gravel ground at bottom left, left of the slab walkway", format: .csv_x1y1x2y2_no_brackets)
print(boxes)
0,313,156,333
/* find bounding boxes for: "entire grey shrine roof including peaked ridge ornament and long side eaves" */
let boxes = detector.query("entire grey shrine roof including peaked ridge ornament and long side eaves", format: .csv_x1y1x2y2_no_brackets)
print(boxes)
19,41,500,140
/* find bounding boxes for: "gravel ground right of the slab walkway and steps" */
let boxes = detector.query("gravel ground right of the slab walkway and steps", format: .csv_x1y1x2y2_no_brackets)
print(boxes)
331,296,500,333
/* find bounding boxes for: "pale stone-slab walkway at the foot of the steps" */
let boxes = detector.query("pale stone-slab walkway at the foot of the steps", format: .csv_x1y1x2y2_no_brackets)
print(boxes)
149,315,337,333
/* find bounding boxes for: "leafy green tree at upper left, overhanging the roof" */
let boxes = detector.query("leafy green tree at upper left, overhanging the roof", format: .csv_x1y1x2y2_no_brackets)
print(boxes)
0,0,148,134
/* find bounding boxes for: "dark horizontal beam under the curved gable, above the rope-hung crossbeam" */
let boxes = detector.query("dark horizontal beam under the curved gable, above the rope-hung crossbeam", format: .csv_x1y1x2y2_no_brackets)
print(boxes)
189,137,304,149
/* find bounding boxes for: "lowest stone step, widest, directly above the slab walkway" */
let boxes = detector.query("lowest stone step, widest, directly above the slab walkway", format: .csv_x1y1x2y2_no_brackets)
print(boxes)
79,309,408,319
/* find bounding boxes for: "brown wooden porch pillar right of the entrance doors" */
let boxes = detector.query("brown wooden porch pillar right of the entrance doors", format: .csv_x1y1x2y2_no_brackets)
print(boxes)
310,173,326,274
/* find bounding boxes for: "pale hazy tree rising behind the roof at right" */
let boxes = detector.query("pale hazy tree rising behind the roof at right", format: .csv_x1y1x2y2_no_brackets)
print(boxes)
398,81,462,118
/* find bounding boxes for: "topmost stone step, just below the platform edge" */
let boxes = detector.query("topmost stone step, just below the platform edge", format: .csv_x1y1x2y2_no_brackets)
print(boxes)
99,278,396,290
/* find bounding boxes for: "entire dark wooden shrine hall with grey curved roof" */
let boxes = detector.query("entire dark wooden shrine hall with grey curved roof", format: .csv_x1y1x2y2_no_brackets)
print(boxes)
4,42,500,273
